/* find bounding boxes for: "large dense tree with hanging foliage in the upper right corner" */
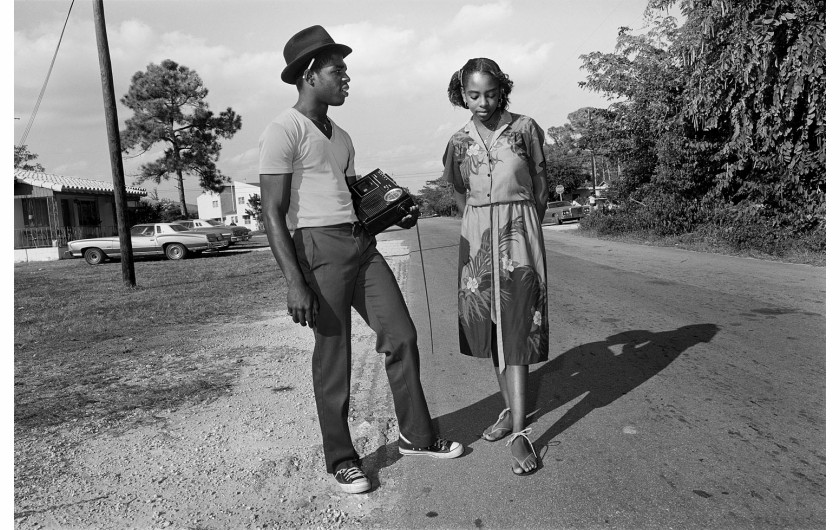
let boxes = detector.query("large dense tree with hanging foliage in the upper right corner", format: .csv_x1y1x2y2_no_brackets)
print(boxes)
582,0,826,233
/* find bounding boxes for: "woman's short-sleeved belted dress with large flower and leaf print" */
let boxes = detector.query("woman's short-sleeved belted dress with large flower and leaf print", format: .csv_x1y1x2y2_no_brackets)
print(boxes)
443,112,548,372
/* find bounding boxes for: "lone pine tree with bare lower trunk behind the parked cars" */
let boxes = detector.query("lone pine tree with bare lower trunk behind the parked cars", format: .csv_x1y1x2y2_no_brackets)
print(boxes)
121,59,242,216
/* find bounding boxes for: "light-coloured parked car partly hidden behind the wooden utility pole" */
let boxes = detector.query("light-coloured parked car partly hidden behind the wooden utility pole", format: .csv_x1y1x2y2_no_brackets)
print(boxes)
64,223,226,265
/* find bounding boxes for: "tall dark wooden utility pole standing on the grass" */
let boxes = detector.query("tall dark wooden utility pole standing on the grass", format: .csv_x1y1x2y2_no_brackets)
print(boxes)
93,0,136,287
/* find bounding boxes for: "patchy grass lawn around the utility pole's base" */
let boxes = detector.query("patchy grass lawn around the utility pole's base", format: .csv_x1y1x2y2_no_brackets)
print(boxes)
14,245,285,436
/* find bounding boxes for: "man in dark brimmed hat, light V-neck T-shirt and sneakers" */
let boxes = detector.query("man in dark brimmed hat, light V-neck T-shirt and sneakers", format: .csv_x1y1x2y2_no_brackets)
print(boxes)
260,26,464,493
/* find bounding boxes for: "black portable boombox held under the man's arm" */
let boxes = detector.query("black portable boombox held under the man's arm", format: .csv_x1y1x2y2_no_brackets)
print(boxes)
349,169,415,236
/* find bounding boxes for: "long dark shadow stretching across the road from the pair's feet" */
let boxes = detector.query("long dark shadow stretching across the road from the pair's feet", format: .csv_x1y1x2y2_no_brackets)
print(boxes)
435,324,720,452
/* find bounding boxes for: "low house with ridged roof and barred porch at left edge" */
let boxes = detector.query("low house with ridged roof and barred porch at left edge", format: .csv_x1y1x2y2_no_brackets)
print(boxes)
14,169,146,261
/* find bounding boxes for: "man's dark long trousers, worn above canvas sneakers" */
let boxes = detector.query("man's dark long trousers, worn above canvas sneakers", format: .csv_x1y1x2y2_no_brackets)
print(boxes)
293,223,435,473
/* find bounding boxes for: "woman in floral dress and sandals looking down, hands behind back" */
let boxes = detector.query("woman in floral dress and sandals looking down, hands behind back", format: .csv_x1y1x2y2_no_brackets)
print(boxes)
443,58,548,475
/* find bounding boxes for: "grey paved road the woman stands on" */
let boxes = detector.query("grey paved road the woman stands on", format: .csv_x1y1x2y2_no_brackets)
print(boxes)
367,219,826,528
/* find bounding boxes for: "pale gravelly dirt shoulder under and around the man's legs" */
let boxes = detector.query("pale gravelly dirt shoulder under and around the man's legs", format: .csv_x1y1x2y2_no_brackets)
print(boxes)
14,242,416,530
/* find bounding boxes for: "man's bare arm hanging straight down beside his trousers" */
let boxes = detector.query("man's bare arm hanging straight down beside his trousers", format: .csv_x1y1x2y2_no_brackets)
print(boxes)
260,173,318,328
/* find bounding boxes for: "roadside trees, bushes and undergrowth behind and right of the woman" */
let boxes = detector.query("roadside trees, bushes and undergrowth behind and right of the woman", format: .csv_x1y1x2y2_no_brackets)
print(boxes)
420,0,826,265
